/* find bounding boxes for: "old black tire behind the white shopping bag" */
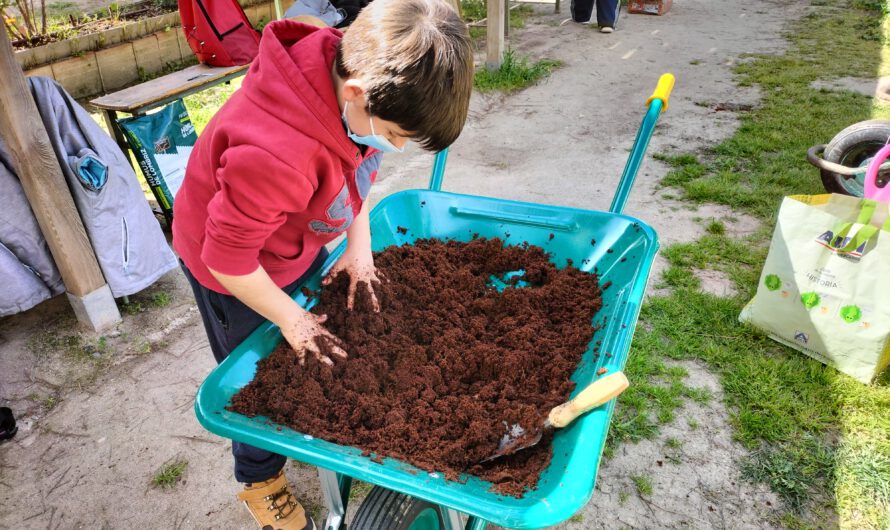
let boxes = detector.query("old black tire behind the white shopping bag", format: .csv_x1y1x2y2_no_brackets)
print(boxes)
821,120,890,197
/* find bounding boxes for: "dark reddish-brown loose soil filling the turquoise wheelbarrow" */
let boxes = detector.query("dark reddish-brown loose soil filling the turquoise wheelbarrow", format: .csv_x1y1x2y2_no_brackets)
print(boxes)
231,239,602,496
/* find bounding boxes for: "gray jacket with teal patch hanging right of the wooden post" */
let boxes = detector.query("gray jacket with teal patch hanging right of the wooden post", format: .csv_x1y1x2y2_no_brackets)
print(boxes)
28,77,177,297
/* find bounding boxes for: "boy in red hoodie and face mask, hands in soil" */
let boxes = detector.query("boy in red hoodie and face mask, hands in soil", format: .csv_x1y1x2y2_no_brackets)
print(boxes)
173,0,473,530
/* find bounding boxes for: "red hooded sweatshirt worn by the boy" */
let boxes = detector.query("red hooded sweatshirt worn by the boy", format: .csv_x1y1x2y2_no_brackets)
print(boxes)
173,20,381,294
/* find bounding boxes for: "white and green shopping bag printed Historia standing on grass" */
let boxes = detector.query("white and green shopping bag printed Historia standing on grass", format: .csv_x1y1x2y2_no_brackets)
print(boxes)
739,194,890,383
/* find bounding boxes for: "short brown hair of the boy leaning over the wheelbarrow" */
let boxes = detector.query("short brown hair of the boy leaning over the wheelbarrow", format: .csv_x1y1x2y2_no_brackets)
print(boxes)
337,0,473,151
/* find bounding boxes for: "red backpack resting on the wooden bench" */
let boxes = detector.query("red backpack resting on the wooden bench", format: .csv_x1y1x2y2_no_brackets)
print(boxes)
179,0,260,66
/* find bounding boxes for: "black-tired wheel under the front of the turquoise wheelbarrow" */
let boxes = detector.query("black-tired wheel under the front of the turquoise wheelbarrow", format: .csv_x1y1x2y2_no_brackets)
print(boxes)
349,486,445,530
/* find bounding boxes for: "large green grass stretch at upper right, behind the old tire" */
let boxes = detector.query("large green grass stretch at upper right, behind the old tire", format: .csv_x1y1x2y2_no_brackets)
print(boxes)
662,5,890,220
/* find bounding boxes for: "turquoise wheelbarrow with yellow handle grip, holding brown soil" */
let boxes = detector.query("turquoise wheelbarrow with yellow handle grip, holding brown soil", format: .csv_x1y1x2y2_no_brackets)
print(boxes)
195,74,674,530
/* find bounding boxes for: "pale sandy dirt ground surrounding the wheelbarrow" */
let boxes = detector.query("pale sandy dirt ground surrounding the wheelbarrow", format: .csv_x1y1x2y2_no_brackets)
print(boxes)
0,0,802,530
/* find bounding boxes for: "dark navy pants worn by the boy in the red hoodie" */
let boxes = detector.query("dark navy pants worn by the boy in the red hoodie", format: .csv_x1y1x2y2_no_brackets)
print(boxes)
179,248,328,482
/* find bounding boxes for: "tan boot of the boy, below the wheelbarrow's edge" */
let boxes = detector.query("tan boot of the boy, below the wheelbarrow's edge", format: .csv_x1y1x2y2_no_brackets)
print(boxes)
238,471,316,530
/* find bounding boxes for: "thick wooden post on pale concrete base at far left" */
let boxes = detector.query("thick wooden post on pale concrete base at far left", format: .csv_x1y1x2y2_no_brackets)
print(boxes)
0,31,121,331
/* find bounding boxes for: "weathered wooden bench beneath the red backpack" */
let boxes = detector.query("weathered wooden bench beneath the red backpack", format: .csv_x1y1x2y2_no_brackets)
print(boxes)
90,64,250,153
